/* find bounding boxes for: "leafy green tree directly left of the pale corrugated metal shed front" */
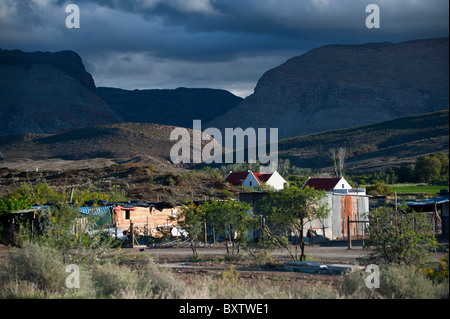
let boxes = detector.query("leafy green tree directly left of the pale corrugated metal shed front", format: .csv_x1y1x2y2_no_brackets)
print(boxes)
260,186,330,260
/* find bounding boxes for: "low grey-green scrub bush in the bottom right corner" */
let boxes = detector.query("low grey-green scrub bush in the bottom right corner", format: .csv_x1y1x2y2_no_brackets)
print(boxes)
340,265,449,299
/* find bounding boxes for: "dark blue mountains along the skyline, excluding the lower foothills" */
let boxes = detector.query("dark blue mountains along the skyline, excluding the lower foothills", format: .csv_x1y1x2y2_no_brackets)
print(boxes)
0,38,449,138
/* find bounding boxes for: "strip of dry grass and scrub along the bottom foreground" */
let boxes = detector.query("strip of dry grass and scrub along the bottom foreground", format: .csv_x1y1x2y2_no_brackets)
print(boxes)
0,245,449,299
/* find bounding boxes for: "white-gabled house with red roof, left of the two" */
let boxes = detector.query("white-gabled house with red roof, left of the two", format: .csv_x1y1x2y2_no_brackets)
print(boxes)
225,171,287,190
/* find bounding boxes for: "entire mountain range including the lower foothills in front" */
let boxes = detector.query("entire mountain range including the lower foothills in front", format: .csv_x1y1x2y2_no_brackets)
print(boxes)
0,38,449,174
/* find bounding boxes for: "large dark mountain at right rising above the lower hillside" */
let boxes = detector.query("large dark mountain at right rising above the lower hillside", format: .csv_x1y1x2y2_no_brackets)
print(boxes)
206,38,449,138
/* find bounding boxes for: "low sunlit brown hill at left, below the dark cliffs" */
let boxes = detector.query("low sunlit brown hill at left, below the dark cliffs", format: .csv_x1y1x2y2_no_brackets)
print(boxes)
0,123,223,167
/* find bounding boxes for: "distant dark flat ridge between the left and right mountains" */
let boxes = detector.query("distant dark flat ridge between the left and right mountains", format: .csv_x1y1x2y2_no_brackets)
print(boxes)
97,87,243,128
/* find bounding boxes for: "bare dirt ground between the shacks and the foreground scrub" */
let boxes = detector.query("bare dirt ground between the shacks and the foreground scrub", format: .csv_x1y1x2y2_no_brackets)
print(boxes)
0,242,445,288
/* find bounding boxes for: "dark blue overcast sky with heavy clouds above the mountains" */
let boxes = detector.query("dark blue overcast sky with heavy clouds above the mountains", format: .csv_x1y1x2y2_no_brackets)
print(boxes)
0,0,449,97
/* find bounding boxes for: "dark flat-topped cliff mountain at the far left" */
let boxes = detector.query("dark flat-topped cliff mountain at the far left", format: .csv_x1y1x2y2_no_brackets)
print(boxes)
0,50,121,135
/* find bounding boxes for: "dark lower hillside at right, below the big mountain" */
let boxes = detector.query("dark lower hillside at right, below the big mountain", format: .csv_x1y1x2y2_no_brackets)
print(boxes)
278,110,449,173
